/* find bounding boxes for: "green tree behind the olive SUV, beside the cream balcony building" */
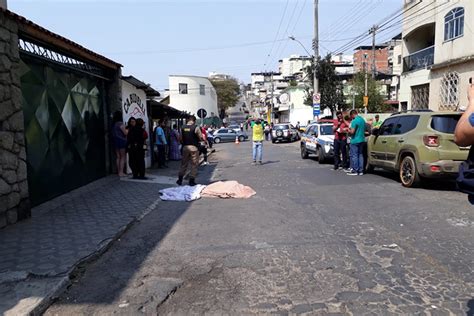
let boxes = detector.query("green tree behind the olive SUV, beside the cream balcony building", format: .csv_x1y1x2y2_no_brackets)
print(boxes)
354,72,390,113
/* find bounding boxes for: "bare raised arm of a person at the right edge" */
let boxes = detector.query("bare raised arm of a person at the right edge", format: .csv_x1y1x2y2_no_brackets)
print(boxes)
454,78,474,146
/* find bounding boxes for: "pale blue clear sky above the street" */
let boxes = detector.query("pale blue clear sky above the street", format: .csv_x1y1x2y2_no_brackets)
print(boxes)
8,0,403,91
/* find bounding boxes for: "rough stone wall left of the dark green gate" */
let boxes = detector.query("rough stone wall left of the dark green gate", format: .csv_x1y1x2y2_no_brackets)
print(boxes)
0,10,31,228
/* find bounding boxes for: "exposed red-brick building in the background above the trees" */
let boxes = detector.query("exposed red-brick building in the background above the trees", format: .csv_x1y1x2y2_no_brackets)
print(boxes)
354,44,390,74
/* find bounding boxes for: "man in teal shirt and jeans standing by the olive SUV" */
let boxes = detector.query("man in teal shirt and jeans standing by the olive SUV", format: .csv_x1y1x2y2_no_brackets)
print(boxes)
348,110,365,176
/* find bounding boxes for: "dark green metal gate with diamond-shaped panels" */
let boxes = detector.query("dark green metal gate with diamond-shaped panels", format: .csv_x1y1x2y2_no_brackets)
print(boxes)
20,54,106,205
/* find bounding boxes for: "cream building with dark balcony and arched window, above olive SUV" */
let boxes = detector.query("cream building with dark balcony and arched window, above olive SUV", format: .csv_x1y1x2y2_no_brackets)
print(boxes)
399,0,474,111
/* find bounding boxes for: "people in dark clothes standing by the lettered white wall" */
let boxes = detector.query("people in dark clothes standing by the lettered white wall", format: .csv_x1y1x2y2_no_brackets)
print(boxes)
112,111,148,179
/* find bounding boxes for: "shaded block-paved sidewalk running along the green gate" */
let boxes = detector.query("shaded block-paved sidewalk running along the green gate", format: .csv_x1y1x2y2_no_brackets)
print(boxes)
0,153,213,315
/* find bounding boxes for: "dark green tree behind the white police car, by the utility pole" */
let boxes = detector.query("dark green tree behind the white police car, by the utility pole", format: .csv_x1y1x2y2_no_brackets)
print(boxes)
305,54,346,113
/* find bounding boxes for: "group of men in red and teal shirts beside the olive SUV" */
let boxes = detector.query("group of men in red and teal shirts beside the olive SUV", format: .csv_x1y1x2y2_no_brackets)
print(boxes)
333,110,382,176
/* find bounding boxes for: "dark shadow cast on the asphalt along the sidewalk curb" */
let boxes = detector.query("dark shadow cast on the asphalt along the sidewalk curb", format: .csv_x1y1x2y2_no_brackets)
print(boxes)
46,165,216,315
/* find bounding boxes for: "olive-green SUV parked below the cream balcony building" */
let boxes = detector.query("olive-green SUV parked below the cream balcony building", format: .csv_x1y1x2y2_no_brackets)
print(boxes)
366,111,469,187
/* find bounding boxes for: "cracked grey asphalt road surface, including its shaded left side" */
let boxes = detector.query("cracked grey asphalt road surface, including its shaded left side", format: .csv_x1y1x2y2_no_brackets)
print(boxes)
46,142,474,315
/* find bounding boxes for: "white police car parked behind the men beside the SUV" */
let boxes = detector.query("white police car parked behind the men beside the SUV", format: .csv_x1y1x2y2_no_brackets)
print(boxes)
300,122,334,164
